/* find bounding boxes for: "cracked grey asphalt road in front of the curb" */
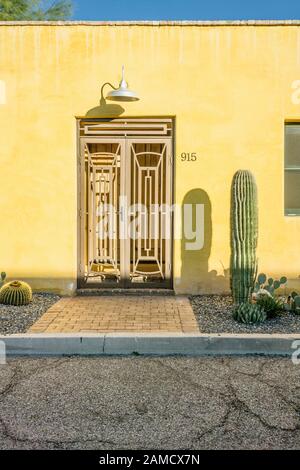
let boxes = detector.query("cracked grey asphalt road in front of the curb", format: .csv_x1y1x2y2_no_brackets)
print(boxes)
0,357,300,450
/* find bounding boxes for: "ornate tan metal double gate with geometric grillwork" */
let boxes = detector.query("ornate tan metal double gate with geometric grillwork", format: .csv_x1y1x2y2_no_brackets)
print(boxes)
79,118,173,287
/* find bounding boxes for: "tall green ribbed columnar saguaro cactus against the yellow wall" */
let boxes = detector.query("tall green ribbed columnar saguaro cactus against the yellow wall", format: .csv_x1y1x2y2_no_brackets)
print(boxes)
230,170,258,303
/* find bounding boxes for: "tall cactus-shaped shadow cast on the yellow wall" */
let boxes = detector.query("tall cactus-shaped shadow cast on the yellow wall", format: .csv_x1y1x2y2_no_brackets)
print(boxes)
180,188,229,294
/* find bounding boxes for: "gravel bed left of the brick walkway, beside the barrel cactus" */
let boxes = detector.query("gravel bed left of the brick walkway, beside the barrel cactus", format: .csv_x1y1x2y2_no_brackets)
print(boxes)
0,294,61,335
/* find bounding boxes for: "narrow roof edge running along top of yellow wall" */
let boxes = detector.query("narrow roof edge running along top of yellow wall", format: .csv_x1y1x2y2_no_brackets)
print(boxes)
0,19,300,26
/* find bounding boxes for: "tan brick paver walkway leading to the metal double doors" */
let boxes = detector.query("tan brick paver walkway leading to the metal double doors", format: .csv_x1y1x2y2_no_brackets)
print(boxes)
28,295,199,333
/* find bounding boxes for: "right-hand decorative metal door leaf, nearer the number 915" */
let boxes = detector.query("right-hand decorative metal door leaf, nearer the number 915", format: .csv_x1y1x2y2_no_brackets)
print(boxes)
125,139,172,286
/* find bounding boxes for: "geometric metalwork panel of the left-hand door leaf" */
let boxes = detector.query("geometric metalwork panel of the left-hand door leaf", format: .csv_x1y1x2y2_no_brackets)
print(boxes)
84,143,121,279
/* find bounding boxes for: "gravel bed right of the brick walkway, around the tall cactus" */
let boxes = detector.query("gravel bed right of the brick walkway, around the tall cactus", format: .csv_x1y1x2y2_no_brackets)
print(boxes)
190,295,300,333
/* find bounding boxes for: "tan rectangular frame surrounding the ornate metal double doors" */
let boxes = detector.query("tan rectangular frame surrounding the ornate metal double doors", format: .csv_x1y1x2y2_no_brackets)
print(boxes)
76,116,175,290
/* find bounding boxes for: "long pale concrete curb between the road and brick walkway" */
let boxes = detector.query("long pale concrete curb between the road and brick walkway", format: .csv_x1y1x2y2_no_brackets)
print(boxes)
0,333,300,356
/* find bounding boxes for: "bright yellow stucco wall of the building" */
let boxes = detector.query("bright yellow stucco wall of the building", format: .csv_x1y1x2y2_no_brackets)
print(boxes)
0,25,300,292
